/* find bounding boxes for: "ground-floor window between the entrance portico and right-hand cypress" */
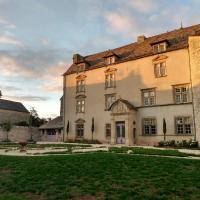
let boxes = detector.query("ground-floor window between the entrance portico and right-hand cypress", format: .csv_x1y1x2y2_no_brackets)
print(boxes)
143,118,157,135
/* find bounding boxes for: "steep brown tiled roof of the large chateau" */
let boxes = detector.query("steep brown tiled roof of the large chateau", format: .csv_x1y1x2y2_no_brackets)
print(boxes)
63,24,200,75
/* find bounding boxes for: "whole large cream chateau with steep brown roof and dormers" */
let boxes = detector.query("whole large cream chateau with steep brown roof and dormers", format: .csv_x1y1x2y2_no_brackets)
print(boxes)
63,25,200,145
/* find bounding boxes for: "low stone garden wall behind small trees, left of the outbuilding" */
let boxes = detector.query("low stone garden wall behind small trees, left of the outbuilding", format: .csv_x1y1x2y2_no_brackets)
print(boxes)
0,126,40,142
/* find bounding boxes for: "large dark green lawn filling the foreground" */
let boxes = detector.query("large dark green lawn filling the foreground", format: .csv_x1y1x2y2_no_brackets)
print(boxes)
0,153,200,200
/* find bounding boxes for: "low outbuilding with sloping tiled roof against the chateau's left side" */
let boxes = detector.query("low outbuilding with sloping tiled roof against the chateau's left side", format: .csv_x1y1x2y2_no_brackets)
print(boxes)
39,116,63,142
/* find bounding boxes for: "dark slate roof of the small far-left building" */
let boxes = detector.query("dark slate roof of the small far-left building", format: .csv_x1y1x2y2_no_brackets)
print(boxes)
0,99,29,113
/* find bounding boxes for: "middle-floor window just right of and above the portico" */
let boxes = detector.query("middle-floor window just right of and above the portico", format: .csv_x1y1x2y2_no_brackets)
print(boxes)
142,89,156,106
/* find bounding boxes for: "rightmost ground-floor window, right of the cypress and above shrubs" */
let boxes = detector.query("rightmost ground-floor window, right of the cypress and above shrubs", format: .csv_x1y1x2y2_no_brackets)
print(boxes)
175,117,192,134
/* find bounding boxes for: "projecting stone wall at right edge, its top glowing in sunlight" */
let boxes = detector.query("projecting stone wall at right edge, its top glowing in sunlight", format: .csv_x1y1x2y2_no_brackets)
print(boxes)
189,36,200,141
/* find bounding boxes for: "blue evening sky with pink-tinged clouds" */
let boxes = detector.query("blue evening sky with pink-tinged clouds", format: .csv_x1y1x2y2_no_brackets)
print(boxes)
0,0,200,118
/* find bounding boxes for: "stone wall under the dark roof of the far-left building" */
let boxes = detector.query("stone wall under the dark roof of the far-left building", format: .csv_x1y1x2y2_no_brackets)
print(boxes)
0,109,30,123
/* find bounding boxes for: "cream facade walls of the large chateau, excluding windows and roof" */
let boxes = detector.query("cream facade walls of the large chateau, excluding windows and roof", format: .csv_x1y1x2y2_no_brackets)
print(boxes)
63,25,200,145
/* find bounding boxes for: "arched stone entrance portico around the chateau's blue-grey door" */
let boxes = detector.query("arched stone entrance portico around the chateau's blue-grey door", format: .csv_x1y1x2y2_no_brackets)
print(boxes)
110,99,137,145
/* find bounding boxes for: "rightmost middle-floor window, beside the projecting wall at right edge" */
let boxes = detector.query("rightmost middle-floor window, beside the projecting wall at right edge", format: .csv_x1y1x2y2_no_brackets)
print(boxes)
174,85,189,104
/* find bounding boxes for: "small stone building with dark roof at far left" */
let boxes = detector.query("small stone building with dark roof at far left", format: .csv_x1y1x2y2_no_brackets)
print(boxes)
0,98,30,124
